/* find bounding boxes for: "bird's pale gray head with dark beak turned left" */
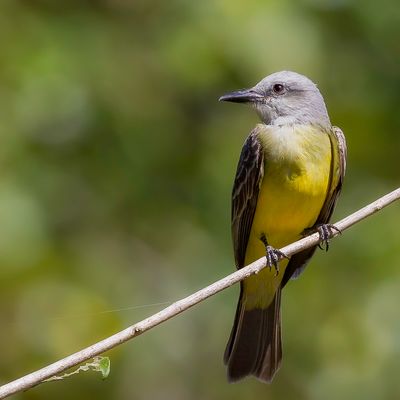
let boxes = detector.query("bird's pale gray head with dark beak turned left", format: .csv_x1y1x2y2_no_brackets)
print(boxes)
219,71,330,127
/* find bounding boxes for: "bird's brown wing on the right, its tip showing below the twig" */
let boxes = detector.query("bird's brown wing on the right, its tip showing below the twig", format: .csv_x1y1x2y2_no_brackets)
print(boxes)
281,126,347,287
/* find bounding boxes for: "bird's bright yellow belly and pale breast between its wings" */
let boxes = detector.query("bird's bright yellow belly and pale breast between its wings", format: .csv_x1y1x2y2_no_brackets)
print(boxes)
244,128,331,309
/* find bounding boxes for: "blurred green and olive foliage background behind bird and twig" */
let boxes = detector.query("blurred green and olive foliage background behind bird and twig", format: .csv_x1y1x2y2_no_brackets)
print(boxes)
0,0,400,400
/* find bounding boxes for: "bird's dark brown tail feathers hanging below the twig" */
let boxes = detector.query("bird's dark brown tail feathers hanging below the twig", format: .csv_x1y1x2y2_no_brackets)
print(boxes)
224,288,282,383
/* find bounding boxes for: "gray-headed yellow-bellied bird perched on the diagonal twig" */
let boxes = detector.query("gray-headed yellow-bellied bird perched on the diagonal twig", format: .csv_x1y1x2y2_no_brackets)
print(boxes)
219,71,347,383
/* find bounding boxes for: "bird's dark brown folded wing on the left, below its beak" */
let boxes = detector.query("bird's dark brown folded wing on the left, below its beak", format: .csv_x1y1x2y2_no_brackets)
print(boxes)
231,129,264,269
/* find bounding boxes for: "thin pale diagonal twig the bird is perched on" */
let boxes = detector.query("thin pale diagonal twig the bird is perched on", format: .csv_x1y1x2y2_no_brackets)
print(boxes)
0,188,400,399
